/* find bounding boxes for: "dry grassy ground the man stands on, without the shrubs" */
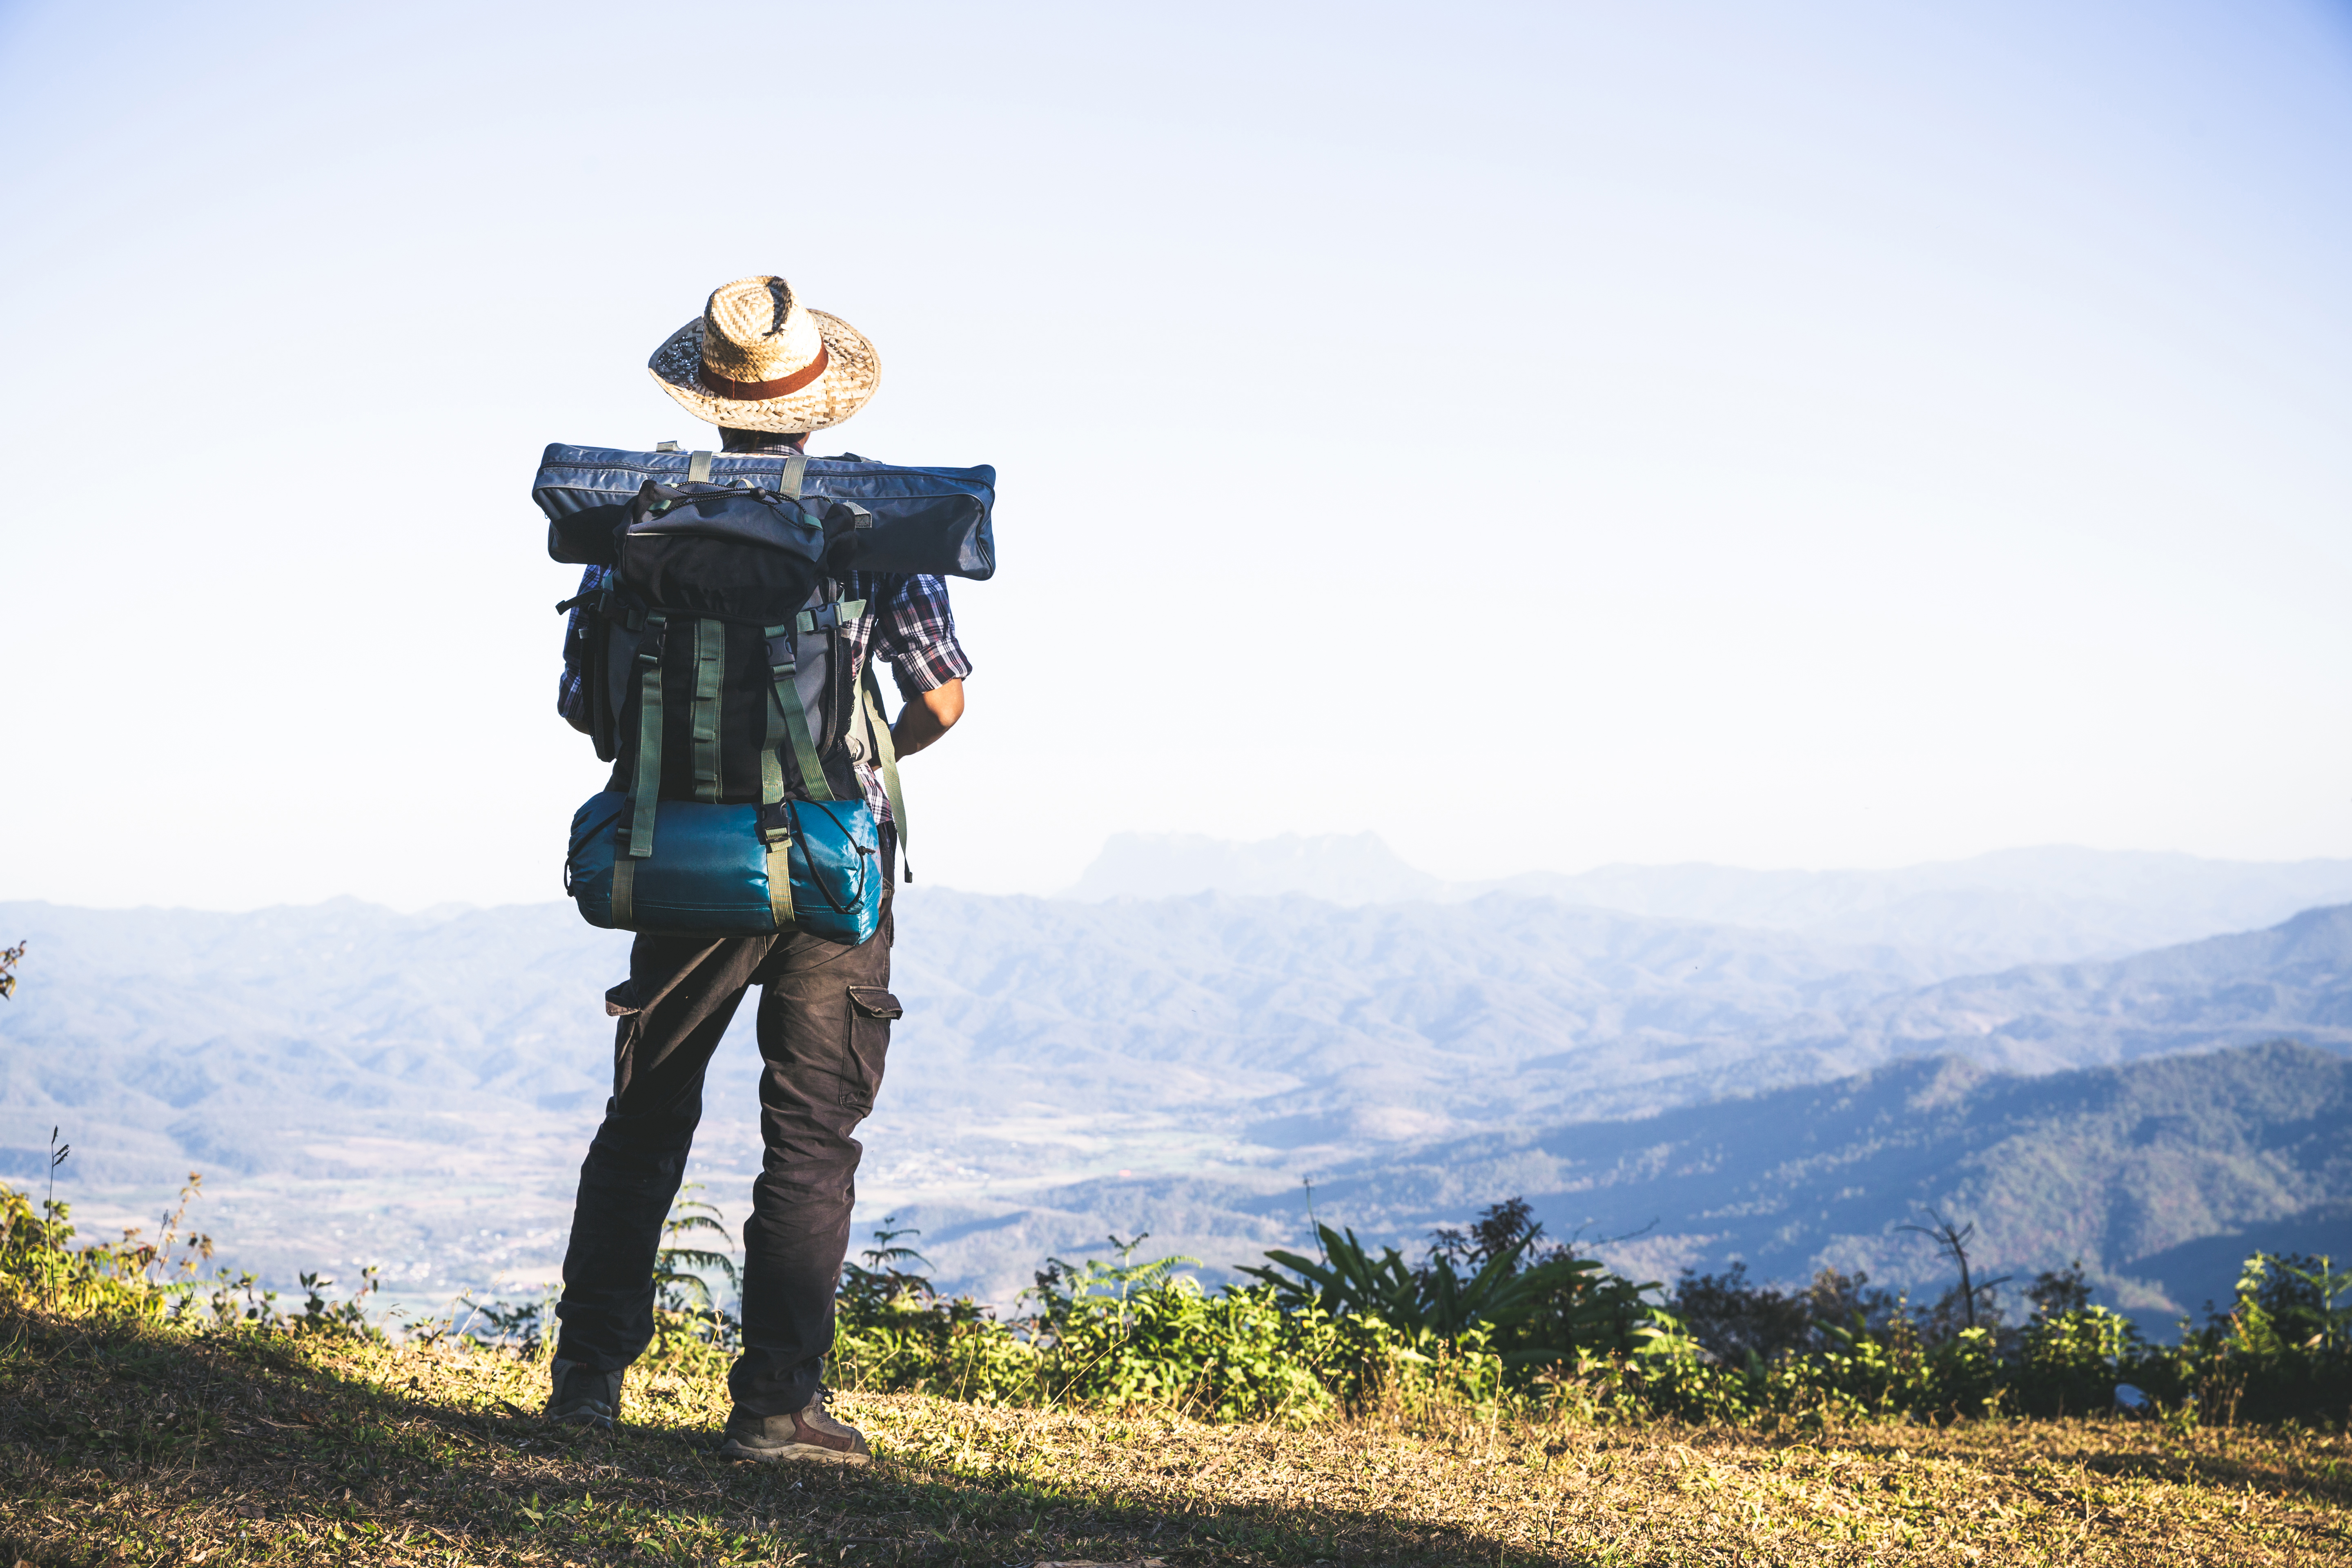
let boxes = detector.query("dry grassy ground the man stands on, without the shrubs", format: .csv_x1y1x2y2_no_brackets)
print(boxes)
0,1316,2352,1566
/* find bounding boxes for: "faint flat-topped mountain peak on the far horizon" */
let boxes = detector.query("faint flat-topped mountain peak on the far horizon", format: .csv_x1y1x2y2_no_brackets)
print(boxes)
1061,832,1444,905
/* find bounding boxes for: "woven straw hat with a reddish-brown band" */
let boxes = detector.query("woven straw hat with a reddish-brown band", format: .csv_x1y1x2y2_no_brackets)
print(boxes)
644,277,882,432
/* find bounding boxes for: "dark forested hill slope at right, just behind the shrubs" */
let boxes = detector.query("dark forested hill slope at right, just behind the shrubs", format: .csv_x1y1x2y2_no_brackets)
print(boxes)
1322,1041,2352,1321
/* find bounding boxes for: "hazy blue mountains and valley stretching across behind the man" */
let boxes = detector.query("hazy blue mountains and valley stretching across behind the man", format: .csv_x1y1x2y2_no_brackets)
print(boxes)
0,839,2352,1310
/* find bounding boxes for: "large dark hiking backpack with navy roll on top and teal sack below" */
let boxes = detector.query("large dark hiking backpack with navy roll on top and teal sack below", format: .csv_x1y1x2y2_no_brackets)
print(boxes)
532,447,995,943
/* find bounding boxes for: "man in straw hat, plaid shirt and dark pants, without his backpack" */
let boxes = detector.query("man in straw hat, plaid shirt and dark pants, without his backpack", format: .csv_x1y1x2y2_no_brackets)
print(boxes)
546,277,971,1465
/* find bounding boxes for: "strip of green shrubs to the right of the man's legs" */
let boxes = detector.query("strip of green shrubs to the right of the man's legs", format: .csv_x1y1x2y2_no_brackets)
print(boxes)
813,1199,2352,1429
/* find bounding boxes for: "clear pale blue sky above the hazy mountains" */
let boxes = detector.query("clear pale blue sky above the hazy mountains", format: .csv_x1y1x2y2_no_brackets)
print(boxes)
0,0,2352,907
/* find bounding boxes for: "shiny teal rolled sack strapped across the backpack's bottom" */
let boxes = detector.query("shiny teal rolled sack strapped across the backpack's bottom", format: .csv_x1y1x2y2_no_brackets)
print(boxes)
564,790,882,945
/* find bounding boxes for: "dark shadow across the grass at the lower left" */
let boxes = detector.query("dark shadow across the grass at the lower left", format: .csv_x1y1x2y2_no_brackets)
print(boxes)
0,1316,1524,1568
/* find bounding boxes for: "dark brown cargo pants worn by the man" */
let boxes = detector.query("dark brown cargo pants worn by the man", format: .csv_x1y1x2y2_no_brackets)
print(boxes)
555,870,898,1415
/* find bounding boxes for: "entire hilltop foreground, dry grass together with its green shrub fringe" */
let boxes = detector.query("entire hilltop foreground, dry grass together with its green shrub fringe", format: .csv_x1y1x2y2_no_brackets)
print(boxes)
0,1189,2352,1568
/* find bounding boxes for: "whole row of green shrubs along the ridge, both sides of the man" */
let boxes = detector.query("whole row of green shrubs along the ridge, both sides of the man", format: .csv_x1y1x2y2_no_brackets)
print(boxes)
0,1178,2352,1425
